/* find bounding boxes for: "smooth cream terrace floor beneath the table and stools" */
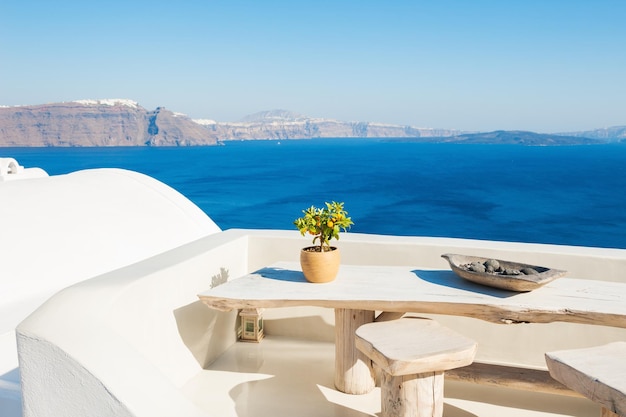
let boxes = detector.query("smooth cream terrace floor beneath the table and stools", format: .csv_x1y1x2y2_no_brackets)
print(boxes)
184,336,600,417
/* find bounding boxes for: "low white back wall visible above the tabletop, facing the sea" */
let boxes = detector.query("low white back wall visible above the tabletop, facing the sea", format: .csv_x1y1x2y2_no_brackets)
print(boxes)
246,230,626,282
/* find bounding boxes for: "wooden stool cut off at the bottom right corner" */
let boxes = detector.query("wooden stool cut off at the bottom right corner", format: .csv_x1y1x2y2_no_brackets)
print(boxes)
546,342,626,417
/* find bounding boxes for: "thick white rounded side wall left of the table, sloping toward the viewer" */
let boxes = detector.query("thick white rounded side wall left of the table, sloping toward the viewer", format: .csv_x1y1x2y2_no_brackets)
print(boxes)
17,232,248,417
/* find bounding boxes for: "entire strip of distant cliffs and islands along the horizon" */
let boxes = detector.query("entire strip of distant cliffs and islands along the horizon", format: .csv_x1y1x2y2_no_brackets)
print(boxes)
0,99,626,147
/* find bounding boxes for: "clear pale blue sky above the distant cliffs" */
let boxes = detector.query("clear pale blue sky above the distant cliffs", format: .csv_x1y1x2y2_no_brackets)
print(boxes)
0,0,626,132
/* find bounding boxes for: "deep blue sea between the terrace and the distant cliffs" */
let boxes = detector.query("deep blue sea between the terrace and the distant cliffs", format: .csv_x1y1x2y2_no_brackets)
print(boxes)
0,139,626,248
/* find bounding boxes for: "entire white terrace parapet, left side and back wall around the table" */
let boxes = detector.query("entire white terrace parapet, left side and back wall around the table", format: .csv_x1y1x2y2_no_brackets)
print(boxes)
17,230,626,417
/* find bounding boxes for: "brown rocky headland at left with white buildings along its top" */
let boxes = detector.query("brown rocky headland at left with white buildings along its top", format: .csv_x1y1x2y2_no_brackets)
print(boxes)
0,100,217,146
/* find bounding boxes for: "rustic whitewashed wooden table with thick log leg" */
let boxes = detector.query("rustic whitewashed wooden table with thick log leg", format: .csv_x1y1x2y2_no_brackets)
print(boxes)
199,262,626,394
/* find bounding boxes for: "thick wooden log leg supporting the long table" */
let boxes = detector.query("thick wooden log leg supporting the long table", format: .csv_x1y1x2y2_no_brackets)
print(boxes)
335,308,375,394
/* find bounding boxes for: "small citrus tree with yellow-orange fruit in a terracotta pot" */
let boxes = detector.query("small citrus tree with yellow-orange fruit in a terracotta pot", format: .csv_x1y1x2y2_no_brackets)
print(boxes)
293,201,354,282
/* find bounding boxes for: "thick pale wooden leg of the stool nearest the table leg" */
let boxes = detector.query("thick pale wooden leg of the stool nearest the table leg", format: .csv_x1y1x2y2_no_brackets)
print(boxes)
380,371,444,417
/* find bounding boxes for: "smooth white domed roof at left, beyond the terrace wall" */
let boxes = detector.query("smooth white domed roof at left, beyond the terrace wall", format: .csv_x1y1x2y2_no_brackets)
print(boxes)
0,167,220,416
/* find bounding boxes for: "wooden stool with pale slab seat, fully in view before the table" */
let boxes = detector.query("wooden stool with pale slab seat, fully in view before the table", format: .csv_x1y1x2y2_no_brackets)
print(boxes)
355,317,476,417
